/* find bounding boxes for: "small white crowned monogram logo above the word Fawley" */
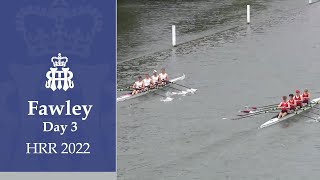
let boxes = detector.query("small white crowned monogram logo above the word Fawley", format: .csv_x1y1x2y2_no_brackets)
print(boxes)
46,53,74,91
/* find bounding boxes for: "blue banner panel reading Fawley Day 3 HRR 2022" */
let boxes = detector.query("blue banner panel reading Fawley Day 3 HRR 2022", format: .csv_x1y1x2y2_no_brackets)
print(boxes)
0,0,116,172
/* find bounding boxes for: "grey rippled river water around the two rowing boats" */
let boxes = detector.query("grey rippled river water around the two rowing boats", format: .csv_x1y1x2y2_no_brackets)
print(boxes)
117,0,320,180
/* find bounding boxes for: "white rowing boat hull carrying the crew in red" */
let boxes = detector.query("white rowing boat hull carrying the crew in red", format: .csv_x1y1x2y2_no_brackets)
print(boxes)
259,98,320,129
